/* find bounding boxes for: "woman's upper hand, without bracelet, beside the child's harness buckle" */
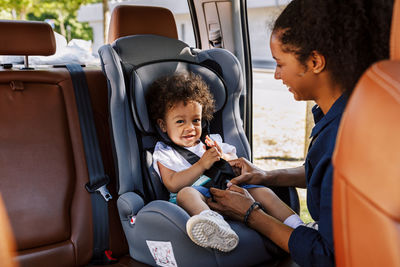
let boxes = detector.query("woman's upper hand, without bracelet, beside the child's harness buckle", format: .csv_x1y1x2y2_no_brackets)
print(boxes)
228,158,267,186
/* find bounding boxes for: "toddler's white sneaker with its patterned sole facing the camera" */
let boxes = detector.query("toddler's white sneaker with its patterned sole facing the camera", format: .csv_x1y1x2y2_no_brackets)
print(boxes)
186,210,239,252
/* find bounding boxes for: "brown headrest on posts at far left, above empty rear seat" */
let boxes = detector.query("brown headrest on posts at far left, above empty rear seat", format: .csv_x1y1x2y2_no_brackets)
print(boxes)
0,20,56,56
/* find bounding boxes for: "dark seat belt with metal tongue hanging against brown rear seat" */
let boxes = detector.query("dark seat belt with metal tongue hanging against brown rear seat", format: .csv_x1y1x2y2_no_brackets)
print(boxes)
66,64,116,264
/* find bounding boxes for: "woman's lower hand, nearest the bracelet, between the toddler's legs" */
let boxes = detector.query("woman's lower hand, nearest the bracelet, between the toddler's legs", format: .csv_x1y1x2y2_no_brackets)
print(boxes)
207,185,254,221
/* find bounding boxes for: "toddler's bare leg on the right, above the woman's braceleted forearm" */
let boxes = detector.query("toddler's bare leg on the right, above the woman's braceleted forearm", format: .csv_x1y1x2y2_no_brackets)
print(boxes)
248,187,295,222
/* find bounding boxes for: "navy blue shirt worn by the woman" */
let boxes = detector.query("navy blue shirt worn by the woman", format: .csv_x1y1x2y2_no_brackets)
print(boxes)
289,94,348,267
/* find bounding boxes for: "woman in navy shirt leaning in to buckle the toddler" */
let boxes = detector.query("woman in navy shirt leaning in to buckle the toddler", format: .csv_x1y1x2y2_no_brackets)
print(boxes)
208,0,393,266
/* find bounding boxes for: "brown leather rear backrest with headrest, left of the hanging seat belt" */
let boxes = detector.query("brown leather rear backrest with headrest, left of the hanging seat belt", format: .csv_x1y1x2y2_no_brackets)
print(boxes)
0,21,93,266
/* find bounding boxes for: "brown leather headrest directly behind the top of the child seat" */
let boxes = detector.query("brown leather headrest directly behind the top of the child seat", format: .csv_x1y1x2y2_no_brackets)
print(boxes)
108,5,178,43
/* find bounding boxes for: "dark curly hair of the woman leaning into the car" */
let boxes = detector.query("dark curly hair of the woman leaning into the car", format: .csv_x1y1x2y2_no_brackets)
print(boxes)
273,0,393,91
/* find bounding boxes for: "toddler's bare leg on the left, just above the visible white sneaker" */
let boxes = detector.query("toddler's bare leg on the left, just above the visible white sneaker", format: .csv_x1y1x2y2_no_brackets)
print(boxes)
176,187,210,216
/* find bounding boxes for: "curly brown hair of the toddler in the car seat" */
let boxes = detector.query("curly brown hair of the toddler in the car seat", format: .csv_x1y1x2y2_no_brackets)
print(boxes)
146,73,215,122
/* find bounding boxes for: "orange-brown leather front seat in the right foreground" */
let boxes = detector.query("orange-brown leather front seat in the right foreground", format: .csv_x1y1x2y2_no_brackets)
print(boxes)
333,0,400,267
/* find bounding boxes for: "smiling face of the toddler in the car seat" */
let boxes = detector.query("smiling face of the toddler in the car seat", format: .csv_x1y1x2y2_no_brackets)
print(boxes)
158,101,202,147
